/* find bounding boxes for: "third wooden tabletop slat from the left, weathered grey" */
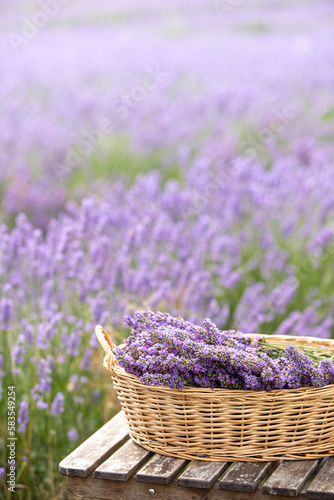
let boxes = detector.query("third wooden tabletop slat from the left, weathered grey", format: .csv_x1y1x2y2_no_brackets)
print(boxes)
137,454,187,484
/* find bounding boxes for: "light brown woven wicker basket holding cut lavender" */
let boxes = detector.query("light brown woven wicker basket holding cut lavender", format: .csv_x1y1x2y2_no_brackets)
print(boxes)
95,326,334,462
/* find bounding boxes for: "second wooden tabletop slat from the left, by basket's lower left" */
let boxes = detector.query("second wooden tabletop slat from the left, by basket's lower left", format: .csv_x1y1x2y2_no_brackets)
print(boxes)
94,439,152,481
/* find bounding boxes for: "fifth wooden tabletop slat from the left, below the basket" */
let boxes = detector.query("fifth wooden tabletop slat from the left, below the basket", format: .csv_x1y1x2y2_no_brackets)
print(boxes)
219,462,275,493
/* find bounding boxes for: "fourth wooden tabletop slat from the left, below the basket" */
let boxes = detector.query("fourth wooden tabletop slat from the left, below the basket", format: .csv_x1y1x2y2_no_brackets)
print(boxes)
177,460,229,489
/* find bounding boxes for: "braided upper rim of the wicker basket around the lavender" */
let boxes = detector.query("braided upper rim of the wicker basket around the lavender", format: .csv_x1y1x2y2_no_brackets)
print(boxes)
110,333,334,397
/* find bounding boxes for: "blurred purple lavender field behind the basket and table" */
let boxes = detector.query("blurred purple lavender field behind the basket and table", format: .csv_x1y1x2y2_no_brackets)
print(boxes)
0,0,334,500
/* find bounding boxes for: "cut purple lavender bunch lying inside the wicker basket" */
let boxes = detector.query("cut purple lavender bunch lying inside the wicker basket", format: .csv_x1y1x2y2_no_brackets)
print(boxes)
115,311,334,391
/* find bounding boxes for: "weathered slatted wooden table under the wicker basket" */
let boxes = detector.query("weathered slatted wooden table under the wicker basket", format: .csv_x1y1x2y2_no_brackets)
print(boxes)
59,412,334,500
